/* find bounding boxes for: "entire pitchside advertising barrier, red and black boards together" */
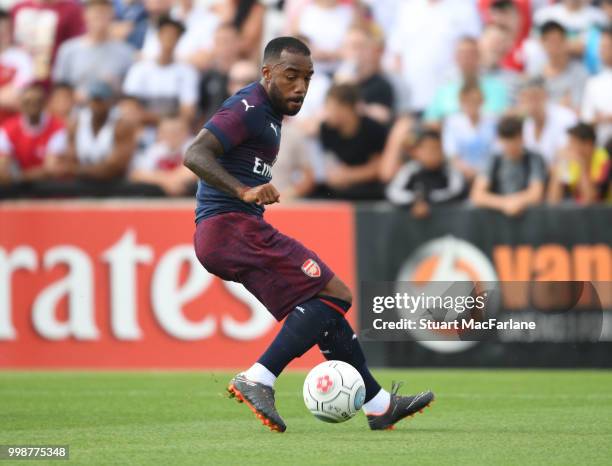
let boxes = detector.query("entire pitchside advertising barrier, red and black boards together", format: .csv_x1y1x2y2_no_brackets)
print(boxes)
0,200,612,369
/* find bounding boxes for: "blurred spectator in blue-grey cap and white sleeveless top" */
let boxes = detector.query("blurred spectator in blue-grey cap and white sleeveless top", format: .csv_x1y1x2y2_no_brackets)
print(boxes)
68,81,135,182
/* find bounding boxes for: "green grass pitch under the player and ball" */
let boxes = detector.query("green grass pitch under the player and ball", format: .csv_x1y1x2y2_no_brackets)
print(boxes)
0,370,612,465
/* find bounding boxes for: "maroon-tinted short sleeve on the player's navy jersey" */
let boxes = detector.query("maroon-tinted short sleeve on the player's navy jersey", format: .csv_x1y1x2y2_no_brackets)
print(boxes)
204,99,266,153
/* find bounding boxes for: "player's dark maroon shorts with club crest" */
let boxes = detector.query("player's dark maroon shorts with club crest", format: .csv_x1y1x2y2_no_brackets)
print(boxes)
194,212,334,321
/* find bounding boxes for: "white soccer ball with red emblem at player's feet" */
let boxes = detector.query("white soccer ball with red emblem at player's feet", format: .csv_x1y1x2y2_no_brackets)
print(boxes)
304,361,365,423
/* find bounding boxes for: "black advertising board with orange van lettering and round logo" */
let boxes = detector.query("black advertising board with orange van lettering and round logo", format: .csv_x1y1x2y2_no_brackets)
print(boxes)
356,205,612,367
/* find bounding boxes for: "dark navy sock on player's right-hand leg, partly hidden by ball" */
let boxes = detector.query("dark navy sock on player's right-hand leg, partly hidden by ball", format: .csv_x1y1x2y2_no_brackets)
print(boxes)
319,303,381,403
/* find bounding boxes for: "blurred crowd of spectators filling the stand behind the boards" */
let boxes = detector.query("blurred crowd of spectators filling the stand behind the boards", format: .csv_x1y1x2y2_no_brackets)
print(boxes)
0,0,612,217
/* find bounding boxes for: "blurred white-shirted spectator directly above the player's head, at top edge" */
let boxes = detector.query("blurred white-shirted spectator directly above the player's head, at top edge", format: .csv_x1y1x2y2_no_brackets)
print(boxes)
292,0,355,74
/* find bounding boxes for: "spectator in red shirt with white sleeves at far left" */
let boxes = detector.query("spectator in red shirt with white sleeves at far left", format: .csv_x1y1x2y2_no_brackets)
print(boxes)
0,83,67,184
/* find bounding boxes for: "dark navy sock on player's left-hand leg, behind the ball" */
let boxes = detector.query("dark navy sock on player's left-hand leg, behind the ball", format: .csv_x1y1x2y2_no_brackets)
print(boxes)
257,298,344,377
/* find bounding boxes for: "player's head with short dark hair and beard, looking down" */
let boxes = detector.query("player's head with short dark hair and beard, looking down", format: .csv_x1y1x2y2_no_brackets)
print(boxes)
261,37,313,115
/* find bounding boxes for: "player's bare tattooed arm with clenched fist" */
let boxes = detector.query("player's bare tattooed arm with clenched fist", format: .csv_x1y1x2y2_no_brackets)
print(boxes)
184,128,280,204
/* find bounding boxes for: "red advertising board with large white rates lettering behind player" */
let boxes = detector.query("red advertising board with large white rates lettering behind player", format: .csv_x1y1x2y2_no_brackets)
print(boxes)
0,201,356,369
